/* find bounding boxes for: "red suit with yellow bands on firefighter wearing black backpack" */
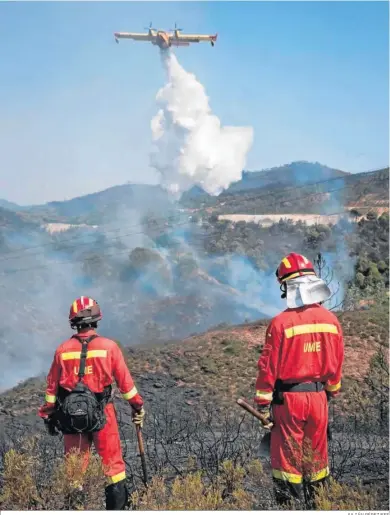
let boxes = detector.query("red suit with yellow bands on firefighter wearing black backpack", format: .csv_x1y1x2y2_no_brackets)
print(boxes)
39,329,143,484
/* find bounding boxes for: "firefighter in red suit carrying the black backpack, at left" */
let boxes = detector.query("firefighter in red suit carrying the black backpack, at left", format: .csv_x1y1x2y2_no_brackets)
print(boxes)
39,297,145,510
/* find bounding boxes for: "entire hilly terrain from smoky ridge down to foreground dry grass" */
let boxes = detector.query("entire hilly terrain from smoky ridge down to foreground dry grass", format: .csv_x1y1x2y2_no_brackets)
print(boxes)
0,162,389,510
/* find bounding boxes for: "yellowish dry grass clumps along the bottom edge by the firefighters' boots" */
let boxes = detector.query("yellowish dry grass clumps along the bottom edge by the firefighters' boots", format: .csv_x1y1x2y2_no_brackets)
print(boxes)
0,439,384,511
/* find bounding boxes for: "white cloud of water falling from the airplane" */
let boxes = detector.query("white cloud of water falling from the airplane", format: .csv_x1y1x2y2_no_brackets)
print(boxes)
151,52,253,195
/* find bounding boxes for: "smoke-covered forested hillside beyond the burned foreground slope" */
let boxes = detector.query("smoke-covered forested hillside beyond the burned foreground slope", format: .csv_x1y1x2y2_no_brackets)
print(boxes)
0,163,389,388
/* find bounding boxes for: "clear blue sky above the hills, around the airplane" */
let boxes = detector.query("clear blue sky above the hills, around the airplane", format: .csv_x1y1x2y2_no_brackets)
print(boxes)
0,1,389,203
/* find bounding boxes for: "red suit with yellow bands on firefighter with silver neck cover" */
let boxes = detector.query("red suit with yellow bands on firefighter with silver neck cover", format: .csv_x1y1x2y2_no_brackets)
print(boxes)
255,304,344,497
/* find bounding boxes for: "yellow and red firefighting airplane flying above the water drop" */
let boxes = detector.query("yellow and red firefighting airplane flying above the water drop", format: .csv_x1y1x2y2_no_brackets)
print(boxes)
114,23,218,50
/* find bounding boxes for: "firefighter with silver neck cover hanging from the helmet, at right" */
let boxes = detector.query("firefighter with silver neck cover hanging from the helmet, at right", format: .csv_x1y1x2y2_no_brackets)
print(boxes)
255,253,344,508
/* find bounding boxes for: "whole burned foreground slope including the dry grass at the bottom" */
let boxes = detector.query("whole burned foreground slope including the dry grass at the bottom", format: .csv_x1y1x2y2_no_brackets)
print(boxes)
0,306,389,510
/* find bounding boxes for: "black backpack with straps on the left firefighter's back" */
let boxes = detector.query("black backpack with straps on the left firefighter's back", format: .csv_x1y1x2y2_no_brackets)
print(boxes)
56,334,107,434
